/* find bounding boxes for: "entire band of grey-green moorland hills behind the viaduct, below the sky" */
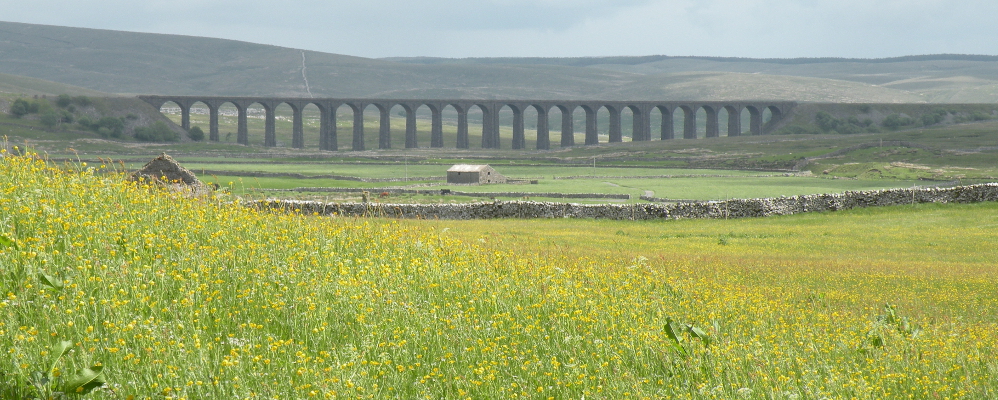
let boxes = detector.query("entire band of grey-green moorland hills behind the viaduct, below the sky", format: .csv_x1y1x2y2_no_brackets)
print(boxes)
0,22,998,103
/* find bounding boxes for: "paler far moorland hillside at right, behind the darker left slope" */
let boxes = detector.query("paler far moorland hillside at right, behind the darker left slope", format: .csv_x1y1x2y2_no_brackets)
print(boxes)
388,54,998,103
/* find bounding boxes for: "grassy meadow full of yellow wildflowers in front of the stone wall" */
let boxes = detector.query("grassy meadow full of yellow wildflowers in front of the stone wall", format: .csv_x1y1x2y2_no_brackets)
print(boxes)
0,148,998,399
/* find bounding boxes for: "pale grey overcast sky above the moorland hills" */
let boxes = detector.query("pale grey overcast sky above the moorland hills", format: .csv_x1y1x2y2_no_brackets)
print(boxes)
0,0,998,58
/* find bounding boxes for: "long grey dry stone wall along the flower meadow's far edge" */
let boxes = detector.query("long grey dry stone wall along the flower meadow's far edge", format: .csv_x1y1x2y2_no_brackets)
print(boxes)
249,183,998,220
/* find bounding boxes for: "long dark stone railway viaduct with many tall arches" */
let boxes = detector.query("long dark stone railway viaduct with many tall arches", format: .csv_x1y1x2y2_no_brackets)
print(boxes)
139,96,796,151
